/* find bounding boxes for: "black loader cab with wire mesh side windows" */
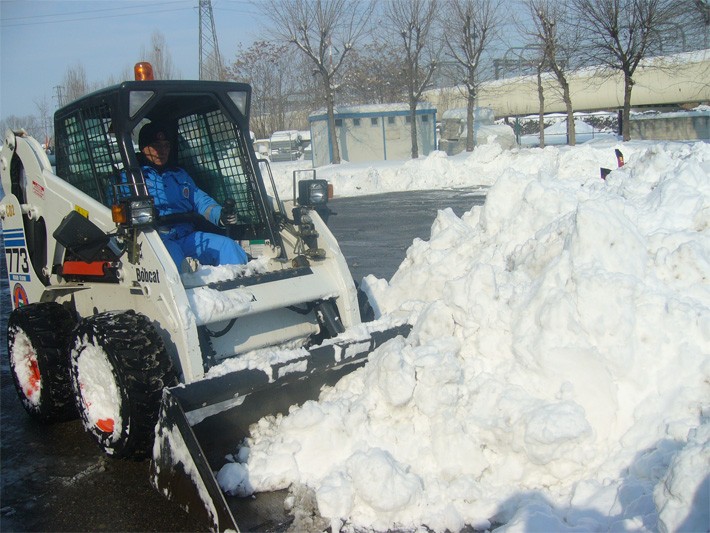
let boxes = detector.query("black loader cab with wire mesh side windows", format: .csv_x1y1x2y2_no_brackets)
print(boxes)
55,81,283,254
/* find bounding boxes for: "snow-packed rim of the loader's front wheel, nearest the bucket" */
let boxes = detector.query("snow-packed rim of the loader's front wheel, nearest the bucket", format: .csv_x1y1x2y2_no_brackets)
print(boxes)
76,346,121,437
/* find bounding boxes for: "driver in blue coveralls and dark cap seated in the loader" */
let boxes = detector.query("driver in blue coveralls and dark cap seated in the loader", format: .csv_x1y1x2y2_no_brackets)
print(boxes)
138,122,247,272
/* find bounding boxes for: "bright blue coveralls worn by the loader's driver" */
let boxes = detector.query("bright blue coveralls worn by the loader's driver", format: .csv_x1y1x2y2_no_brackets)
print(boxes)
142,166,247,268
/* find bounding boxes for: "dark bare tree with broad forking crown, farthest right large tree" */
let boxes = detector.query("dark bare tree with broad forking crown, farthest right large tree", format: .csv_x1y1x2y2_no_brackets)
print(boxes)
573,0,681,141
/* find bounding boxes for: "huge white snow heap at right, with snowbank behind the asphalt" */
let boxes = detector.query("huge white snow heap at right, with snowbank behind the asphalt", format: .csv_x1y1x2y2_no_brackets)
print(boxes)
218,142,710,531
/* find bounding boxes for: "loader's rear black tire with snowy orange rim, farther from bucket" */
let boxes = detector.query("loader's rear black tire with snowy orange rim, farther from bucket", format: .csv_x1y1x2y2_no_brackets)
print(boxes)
7,302,77,423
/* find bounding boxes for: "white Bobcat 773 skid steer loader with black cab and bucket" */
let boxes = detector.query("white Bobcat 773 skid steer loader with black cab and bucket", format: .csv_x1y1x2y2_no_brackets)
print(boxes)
0,65,408,530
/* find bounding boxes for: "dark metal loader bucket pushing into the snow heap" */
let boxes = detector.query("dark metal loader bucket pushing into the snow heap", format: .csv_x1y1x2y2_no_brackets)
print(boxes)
151,324,411,531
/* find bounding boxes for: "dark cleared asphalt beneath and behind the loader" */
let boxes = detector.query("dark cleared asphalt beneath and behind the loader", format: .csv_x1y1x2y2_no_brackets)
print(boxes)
0,189,485,532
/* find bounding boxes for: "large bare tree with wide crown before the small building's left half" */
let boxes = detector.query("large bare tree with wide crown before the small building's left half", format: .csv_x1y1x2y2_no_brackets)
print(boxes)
268,0,374,164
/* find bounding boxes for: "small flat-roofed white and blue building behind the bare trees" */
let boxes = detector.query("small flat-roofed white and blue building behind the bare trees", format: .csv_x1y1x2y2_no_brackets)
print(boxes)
308,104,437,167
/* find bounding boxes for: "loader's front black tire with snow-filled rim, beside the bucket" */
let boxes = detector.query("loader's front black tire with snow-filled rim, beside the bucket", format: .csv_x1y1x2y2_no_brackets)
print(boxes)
70,311,177,460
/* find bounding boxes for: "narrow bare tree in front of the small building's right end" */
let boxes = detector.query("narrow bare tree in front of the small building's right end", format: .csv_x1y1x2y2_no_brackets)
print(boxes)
385,0,438,159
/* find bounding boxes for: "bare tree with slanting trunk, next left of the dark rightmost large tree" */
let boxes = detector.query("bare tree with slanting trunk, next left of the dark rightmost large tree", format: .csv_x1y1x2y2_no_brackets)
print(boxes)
525,0,580,146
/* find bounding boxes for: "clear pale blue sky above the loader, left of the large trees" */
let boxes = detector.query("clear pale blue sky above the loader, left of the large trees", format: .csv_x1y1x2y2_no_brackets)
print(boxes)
0,0,268,118
